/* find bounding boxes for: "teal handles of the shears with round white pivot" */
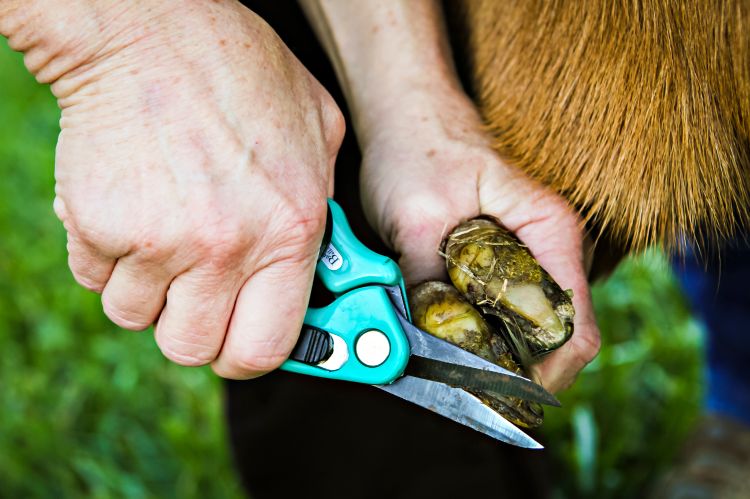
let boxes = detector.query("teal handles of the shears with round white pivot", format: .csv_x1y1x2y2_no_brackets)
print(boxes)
281,199,410,384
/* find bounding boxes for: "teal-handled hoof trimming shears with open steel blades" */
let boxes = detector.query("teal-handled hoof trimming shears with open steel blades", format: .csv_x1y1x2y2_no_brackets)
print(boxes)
281,200,559,448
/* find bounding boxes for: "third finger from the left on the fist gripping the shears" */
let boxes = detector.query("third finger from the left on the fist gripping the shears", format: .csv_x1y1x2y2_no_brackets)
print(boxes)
154,268,242,366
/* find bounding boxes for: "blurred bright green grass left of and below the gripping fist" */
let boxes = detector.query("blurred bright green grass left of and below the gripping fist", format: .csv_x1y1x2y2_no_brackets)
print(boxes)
0,43,242,497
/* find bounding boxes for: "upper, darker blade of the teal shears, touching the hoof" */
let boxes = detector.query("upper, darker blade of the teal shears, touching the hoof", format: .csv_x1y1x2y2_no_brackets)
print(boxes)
406,355,560,407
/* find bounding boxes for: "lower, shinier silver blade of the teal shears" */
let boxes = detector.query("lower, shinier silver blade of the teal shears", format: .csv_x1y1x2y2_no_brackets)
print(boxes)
378,376,543,449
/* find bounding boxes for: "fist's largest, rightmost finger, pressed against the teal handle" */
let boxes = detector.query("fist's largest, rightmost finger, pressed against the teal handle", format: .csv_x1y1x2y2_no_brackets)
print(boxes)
212,256,315,379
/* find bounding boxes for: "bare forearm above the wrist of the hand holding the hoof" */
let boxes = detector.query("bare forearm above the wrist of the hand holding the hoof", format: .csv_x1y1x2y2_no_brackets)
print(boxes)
300,0,465,144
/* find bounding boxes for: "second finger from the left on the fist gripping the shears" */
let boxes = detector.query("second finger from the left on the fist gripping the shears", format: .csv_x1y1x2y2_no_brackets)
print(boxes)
102,255,172,331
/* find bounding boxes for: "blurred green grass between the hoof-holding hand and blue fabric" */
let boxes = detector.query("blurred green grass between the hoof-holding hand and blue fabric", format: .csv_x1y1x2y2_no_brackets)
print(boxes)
544,252,702,498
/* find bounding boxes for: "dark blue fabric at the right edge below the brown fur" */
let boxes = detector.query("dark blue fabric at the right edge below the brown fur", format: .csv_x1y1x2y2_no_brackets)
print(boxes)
674,243,750,425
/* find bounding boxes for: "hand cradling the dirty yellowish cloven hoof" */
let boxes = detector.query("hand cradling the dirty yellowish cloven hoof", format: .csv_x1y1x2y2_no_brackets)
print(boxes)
361,92,599,392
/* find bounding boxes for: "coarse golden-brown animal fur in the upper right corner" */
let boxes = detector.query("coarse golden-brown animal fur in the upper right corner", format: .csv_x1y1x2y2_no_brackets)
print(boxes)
448,0,750,254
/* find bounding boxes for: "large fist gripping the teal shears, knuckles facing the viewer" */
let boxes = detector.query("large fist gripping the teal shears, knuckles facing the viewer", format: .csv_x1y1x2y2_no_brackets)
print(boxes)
9,0,344,379
